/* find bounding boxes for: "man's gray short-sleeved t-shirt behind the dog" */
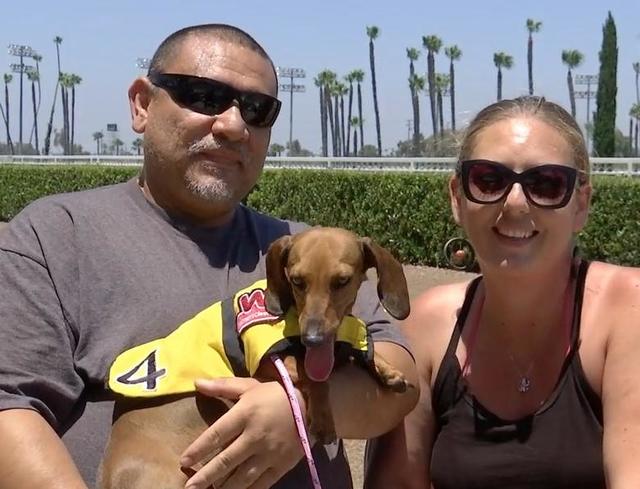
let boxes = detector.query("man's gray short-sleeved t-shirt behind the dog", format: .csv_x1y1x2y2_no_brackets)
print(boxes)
0,180,404,489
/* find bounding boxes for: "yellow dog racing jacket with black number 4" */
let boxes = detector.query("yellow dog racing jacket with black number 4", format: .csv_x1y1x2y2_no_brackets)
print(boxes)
107,279,373,397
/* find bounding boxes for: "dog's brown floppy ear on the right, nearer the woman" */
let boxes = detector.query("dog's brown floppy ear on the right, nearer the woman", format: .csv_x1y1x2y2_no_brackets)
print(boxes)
360,238,410,319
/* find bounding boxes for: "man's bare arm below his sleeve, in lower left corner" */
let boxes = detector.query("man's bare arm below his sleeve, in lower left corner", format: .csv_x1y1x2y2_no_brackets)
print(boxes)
0,409,87,489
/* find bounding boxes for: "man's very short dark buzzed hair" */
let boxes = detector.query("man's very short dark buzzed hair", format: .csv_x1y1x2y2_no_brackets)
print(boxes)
149,24,278,90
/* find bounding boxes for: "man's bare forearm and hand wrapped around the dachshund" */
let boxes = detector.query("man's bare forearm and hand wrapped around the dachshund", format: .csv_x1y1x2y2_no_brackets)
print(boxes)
181,342,419,489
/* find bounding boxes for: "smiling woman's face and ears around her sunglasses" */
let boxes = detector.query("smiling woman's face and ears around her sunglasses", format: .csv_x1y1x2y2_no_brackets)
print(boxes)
450,116,591,271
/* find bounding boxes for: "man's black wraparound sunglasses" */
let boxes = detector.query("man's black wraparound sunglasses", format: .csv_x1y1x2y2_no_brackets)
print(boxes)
148,73,281,127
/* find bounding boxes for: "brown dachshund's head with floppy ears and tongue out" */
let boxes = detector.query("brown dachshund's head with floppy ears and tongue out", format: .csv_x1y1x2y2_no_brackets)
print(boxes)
265,227,409,381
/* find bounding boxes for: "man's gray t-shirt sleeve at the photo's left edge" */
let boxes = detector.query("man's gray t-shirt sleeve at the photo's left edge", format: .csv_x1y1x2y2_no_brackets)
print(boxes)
0,204,84,431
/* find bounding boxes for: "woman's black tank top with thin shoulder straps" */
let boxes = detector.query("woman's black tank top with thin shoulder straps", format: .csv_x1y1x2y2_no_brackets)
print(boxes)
431,262,605,489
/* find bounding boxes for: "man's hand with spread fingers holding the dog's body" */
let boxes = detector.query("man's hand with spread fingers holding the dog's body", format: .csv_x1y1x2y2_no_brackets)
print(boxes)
180,378,304,489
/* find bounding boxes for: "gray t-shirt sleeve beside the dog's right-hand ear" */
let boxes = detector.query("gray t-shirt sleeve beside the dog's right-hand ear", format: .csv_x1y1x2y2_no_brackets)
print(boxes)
353,280,411,353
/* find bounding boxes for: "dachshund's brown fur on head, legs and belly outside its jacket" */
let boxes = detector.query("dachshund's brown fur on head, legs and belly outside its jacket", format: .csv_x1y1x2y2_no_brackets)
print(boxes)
98,228,409,489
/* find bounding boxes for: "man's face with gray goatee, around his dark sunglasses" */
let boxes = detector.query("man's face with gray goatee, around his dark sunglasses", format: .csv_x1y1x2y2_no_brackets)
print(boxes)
130,35,277,223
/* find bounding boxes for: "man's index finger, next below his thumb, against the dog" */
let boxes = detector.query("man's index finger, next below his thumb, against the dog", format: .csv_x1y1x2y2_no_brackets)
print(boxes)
180,411,244,467
